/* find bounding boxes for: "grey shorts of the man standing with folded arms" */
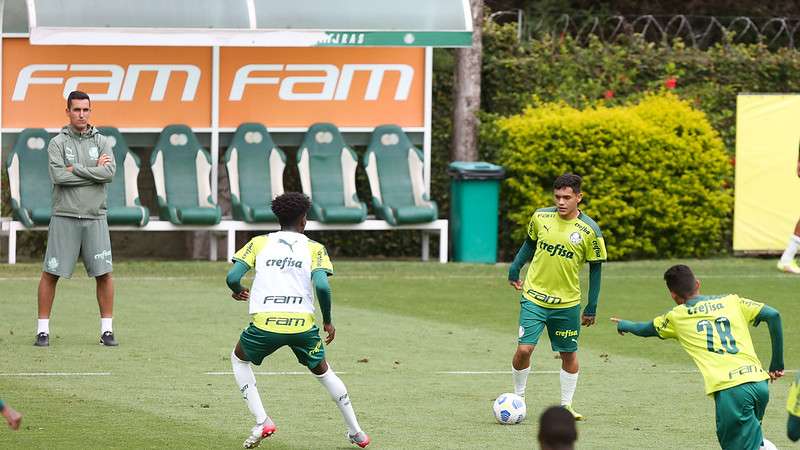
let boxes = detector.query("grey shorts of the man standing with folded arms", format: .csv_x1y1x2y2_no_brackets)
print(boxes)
43,216,112,278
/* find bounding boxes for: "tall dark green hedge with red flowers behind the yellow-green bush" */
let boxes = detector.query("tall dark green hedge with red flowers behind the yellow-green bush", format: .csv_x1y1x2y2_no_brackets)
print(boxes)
481,22,800,161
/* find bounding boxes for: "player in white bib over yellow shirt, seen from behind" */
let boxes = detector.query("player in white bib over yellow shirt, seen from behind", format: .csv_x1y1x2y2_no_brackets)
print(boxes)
226,192,370,448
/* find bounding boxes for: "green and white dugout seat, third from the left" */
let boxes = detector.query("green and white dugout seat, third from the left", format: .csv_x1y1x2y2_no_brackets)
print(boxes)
150,125,222,225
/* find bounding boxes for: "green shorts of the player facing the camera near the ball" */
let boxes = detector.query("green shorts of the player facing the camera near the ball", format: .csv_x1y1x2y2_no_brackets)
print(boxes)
519,298,581,352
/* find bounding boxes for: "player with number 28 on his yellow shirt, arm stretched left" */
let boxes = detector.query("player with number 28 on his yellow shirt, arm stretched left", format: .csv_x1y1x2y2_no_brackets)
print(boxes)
611,265,783,450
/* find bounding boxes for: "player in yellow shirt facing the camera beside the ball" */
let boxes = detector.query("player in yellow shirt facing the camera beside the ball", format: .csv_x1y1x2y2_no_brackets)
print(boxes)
508,173,606,420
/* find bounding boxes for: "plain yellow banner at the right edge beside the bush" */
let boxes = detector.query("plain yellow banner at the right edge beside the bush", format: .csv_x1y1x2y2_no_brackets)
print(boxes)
733,95,800,252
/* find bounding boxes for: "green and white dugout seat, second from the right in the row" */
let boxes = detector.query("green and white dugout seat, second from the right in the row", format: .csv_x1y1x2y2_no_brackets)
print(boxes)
297,123,367,223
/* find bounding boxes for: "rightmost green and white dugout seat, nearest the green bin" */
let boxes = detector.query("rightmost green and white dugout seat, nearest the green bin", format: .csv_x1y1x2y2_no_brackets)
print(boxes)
364,125,438,225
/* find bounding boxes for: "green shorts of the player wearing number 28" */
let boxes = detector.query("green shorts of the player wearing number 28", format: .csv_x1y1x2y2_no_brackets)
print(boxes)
714,380,769,450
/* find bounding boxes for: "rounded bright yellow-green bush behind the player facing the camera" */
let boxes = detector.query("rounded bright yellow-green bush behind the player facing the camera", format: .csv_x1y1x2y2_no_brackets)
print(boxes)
484,94,733,259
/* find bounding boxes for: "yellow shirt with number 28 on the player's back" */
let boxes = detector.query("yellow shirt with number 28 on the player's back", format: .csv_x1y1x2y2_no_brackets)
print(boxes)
653,295,769,394
